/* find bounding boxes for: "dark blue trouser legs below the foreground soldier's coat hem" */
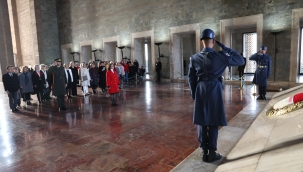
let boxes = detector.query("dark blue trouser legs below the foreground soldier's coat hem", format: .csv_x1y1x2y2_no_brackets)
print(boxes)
197,125,219,151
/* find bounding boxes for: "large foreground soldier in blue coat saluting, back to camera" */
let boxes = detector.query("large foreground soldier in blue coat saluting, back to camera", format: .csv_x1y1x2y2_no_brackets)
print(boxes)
188,29,244,162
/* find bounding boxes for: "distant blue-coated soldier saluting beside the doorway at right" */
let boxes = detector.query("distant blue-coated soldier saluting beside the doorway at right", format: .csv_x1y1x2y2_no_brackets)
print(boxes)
249,45,272,100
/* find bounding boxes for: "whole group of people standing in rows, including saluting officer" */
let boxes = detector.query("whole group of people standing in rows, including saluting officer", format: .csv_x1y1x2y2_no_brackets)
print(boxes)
3,58,145,111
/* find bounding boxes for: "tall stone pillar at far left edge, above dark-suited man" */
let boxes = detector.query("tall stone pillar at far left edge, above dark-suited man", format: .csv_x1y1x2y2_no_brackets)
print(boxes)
0,1,14,81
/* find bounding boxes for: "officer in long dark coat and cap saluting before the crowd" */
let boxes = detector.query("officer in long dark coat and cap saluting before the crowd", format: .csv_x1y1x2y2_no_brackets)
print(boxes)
48,58,67,111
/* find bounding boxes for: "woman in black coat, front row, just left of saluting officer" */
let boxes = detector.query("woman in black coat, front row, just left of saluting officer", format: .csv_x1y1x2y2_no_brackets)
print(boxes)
32,65,46,104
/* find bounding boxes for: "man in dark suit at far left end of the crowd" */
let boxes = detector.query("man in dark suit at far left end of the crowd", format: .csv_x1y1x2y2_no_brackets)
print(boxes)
2,65,20,112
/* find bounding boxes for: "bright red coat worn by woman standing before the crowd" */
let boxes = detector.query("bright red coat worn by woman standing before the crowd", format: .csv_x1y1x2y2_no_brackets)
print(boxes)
106,70,120,94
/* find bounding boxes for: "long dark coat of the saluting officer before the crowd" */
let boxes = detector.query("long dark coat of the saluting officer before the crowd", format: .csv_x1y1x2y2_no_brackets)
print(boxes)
48,66,67,96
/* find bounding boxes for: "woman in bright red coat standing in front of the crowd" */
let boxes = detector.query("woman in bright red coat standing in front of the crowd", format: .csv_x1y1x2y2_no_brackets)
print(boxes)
106,63,120,106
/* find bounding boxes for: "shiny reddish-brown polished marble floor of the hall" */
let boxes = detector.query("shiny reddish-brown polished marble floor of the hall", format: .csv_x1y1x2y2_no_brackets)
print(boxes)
0,81,254,172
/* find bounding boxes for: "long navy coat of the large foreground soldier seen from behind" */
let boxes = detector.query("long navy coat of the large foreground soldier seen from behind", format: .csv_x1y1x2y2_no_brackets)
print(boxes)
188,48,244,126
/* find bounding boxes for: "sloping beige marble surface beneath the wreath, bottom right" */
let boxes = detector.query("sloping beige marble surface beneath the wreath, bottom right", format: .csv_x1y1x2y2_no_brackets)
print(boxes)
216,86,303,172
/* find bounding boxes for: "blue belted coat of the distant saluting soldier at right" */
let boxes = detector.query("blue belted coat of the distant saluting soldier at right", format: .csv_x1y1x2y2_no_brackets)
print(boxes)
249,53,271,86
